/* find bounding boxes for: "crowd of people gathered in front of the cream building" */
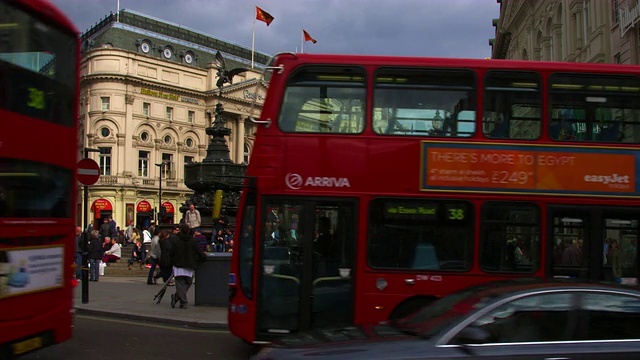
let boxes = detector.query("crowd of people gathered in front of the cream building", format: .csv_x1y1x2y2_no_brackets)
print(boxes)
76,211,233,308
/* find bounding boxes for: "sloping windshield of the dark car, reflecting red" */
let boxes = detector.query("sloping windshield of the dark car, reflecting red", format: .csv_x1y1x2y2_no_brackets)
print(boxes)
391,286,508,338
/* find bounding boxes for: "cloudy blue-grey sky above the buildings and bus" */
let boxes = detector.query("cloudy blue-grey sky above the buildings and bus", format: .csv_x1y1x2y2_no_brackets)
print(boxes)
50,0,500,59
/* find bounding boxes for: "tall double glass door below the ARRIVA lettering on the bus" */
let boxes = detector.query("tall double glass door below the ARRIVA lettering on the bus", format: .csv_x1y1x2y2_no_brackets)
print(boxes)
257,198,358,334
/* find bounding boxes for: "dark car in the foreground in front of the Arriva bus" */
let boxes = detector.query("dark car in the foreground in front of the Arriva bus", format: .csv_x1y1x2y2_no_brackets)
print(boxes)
254,280,640,360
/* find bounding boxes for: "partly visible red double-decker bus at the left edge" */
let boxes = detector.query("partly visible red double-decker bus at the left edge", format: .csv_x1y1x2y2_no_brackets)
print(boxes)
0,0,79,359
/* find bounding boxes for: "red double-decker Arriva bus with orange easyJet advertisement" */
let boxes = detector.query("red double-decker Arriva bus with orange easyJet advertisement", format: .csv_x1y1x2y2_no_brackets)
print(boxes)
228,53,640,343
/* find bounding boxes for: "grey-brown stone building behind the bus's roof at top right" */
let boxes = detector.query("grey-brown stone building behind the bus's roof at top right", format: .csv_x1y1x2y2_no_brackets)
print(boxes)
489,0,640,64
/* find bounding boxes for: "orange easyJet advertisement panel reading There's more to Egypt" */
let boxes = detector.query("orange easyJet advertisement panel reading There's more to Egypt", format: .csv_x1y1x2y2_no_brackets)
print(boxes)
420,141,640,197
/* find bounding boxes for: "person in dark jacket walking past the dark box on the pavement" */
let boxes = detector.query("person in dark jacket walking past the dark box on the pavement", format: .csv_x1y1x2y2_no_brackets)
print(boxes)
171,224,207,309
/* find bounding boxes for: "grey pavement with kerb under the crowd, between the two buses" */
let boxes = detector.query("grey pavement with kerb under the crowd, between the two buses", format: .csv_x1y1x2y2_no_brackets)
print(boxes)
73,275,227,329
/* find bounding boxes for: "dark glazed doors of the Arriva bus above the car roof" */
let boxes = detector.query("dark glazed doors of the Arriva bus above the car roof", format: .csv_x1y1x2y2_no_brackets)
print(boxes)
547,205,640,284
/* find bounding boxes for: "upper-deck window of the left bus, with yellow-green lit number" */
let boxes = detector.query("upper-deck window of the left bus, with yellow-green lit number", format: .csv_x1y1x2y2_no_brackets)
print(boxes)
0,2,77,127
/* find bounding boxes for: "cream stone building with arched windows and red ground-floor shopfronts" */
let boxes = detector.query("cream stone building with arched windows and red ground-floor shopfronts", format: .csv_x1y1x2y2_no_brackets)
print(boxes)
78,10,269,231
